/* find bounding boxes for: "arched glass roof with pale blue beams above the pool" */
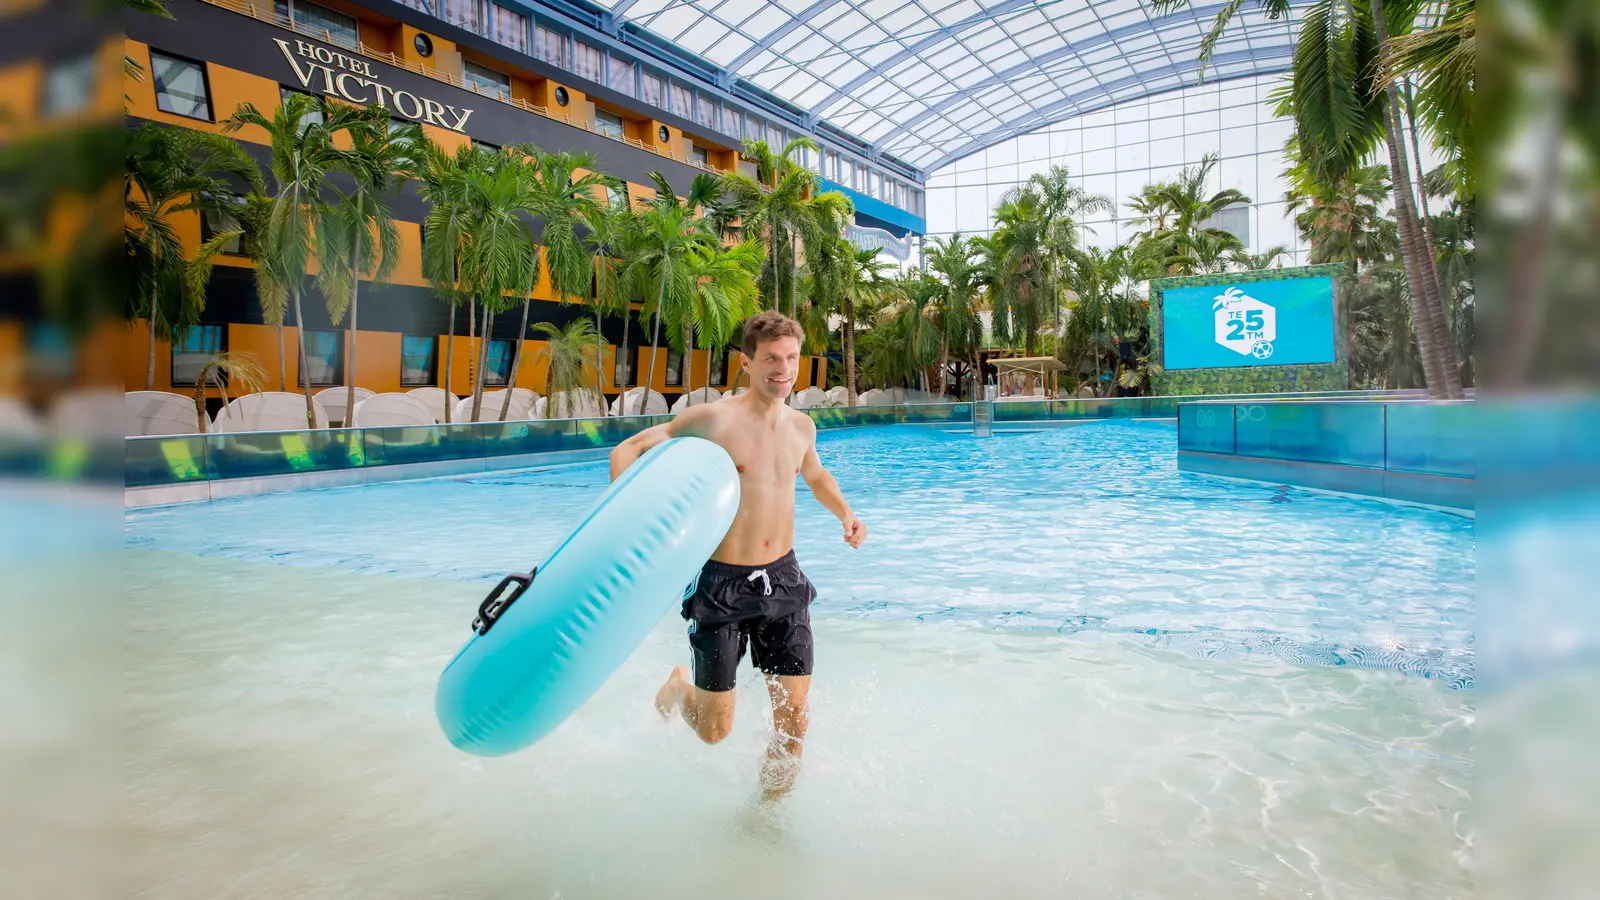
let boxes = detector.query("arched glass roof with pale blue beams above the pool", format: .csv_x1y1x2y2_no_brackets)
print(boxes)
598,0,1309,171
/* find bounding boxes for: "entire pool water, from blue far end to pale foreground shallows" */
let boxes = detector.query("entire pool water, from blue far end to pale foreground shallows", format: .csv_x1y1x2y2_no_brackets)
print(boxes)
125,423,1475,898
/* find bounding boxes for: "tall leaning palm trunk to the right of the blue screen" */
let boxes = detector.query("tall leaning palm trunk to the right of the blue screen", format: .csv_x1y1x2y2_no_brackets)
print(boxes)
1371,0,1464,400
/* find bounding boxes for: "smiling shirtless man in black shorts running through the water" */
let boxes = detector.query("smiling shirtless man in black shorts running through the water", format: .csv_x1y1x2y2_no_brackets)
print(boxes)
611,312,867,798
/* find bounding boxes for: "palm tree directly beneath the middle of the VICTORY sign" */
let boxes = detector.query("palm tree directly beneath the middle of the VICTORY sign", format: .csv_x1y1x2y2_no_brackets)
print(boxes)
318,106,427,424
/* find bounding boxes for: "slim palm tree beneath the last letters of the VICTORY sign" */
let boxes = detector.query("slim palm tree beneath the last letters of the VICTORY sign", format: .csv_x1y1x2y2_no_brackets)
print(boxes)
418,141,488,424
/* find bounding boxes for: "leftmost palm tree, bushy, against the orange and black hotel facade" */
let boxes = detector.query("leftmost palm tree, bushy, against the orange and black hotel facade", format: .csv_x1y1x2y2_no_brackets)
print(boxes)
123,122,261,391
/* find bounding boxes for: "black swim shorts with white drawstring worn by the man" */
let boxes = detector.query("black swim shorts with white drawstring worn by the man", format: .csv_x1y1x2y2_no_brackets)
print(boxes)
683,551,816,690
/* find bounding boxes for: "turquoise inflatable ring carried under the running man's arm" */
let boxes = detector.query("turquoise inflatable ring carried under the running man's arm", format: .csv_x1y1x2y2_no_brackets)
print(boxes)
434,437,739,756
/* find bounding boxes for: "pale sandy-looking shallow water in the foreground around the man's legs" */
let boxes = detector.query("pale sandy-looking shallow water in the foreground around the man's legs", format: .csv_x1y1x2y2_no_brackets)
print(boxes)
125,549,1474,900
